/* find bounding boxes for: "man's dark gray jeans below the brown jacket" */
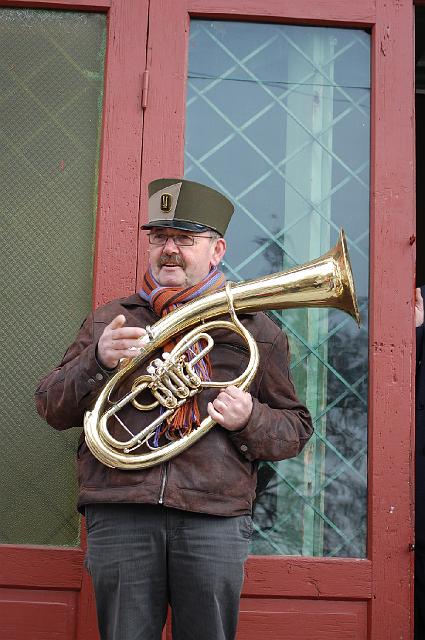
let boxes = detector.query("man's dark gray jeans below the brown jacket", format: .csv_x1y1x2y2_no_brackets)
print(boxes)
86,504,252,640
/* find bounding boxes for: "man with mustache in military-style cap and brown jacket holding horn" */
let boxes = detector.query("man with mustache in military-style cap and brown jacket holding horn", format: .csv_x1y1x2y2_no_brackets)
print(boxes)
37,179,312,640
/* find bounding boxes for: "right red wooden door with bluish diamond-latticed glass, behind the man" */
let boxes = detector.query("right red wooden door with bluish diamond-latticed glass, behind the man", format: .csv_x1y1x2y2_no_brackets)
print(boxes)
139,0,414,640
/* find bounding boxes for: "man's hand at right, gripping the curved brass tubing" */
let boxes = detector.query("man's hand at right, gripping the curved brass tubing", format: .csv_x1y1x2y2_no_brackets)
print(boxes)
208,385,252,431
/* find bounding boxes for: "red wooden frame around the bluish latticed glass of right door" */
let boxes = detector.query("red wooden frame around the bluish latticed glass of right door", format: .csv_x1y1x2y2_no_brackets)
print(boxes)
138,0,415,640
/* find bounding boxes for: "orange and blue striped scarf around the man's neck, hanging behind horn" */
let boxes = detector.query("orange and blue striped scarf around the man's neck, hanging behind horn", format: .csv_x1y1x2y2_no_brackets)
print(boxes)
139,267,226,447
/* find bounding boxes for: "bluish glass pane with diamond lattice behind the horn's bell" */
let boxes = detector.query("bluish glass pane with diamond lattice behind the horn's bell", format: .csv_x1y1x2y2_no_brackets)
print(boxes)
185,20,370,557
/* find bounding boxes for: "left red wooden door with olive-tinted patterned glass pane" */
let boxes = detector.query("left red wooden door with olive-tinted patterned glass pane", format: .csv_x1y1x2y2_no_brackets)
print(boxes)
0,0,148,640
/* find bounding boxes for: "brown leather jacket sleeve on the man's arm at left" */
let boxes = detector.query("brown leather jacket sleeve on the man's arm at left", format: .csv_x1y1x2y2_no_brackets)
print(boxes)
35,314,114,429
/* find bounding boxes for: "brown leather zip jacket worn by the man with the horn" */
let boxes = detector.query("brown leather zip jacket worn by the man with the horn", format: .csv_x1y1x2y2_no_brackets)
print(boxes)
36,294,313,516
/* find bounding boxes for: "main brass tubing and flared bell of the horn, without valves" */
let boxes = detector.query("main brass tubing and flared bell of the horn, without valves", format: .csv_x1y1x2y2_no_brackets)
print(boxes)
84,229,360,469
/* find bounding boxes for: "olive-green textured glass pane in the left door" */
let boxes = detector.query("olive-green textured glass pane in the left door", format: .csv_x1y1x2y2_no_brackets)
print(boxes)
0,9,106,545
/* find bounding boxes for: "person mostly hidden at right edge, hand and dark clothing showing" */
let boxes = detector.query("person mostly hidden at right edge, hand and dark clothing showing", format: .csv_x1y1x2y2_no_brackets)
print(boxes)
415,287,425,640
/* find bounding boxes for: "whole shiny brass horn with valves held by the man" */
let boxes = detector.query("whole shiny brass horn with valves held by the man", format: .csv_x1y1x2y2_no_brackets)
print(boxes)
84,229,360,470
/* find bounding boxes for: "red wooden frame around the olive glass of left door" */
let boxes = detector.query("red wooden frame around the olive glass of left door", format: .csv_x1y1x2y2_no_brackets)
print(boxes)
0,0,149,640
